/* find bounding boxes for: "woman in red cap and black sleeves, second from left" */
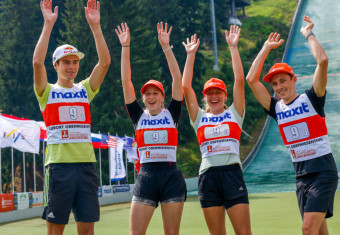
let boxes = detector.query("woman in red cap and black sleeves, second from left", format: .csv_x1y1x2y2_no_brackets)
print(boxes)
116,22,186,234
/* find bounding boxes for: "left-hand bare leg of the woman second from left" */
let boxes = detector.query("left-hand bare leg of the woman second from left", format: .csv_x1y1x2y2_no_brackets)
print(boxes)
130,202,156,235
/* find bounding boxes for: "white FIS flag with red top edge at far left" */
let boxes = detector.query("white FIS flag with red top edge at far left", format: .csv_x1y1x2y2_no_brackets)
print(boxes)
0,114,40,153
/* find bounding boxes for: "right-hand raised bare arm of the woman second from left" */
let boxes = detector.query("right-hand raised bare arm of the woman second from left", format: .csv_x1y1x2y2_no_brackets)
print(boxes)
157,22,183,101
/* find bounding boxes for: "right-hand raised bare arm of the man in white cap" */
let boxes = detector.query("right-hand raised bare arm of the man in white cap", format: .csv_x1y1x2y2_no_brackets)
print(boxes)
85,0,111,91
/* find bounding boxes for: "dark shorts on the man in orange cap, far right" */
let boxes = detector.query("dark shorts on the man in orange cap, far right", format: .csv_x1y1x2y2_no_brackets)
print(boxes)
296,171,338,218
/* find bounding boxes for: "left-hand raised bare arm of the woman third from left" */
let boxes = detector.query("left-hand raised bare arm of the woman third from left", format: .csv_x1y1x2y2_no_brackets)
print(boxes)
182,34,200,122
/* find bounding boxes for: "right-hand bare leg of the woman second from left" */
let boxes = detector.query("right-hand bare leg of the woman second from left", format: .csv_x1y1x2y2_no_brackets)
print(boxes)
161,202,184,235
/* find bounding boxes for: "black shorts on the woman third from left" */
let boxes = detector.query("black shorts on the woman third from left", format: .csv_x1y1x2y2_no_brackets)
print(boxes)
198,164,249,209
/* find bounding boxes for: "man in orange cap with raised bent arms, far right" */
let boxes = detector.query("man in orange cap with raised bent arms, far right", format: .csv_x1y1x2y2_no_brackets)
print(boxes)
247,16,338,235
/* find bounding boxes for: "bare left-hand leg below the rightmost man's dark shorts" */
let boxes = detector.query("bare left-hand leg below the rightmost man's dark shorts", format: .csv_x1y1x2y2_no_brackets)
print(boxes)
302,212,326,235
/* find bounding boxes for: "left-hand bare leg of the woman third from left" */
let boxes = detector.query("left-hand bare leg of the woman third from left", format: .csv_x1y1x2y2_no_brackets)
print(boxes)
202,206,227,235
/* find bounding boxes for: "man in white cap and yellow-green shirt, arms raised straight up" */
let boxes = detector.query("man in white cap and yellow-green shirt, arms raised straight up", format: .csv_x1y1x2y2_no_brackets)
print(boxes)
33,0,111,235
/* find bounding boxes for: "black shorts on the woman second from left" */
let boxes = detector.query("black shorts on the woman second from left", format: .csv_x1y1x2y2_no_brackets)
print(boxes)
133,162,187,207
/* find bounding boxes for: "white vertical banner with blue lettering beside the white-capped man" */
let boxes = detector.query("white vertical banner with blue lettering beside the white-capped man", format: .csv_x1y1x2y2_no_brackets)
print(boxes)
108,136,126,181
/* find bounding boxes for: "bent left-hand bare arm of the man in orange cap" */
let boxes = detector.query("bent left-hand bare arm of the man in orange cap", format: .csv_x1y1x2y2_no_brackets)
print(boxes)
246,32,284,111
